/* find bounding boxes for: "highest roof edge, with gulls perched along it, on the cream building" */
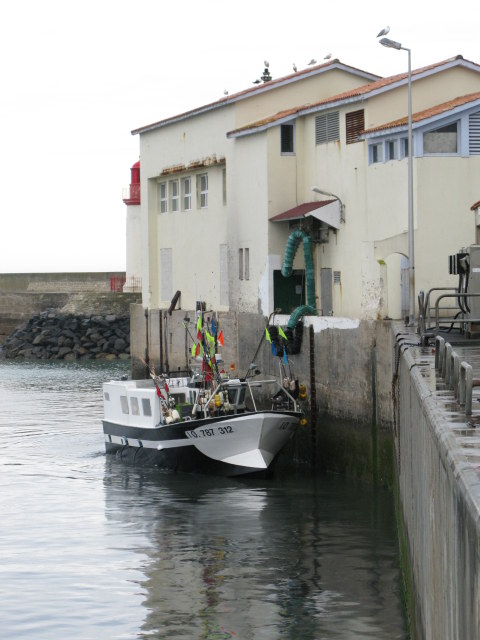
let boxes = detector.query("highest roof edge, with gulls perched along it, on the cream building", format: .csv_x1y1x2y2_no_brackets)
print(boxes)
131,59,379,135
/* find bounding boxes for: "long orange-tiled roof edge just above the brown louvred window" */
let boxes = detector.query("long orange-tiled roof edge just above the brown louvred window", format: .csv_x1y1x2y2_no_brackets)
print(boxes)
227,55,480,137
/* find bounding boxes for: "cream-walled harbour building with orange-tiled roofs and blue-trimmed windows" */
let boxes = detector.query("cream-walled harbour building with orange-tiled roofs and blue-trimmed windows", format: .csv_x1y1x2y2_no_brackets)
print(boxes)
129,56,480,319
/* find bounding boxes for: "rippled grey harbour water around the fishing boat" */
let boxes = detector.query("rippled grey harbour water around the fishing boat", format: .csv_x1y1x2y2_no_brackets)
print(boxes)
0,361,408,640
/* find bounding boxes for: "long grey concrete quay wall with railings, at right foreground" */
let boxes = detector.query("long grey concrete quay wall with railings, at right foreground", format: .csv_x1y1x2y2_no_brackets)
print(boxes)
394,338,480,640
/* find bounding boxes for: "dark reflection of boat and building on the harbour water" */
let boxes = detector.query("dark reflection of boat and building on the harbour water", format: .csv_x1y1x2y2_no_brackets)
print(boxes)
105,457,407,640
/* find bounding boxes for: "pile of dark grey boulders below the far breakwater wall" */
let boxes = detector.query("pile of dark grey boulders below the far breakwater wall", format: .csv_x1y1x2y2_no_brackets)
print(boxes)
0,311,130,361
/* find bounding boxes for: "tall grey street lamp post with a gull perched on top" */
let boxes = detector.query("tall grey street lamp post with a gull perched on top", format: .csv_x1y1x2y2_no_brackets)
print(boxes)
379,38,415,327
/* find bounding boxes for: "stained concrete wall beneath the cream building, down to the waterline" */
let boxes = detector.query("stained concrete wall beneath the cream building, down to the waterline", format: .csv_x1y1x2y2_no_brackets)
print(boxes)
130,304,393,487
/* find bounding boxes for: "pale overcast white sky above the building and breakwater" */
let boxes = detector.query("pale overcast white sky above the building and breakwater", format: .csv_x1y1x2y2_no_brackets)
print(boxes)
0,0,480,273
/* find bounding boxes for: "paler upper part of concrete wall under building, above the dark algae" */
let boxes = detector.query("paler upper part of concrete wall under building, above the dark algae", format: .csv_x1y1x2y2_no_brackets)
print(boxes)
131,305,393,428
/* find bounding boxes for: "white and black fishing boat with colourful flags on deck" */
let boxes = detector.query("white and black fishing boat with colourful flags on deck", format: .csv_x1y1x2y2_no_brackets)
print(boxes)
103,312,303,476
